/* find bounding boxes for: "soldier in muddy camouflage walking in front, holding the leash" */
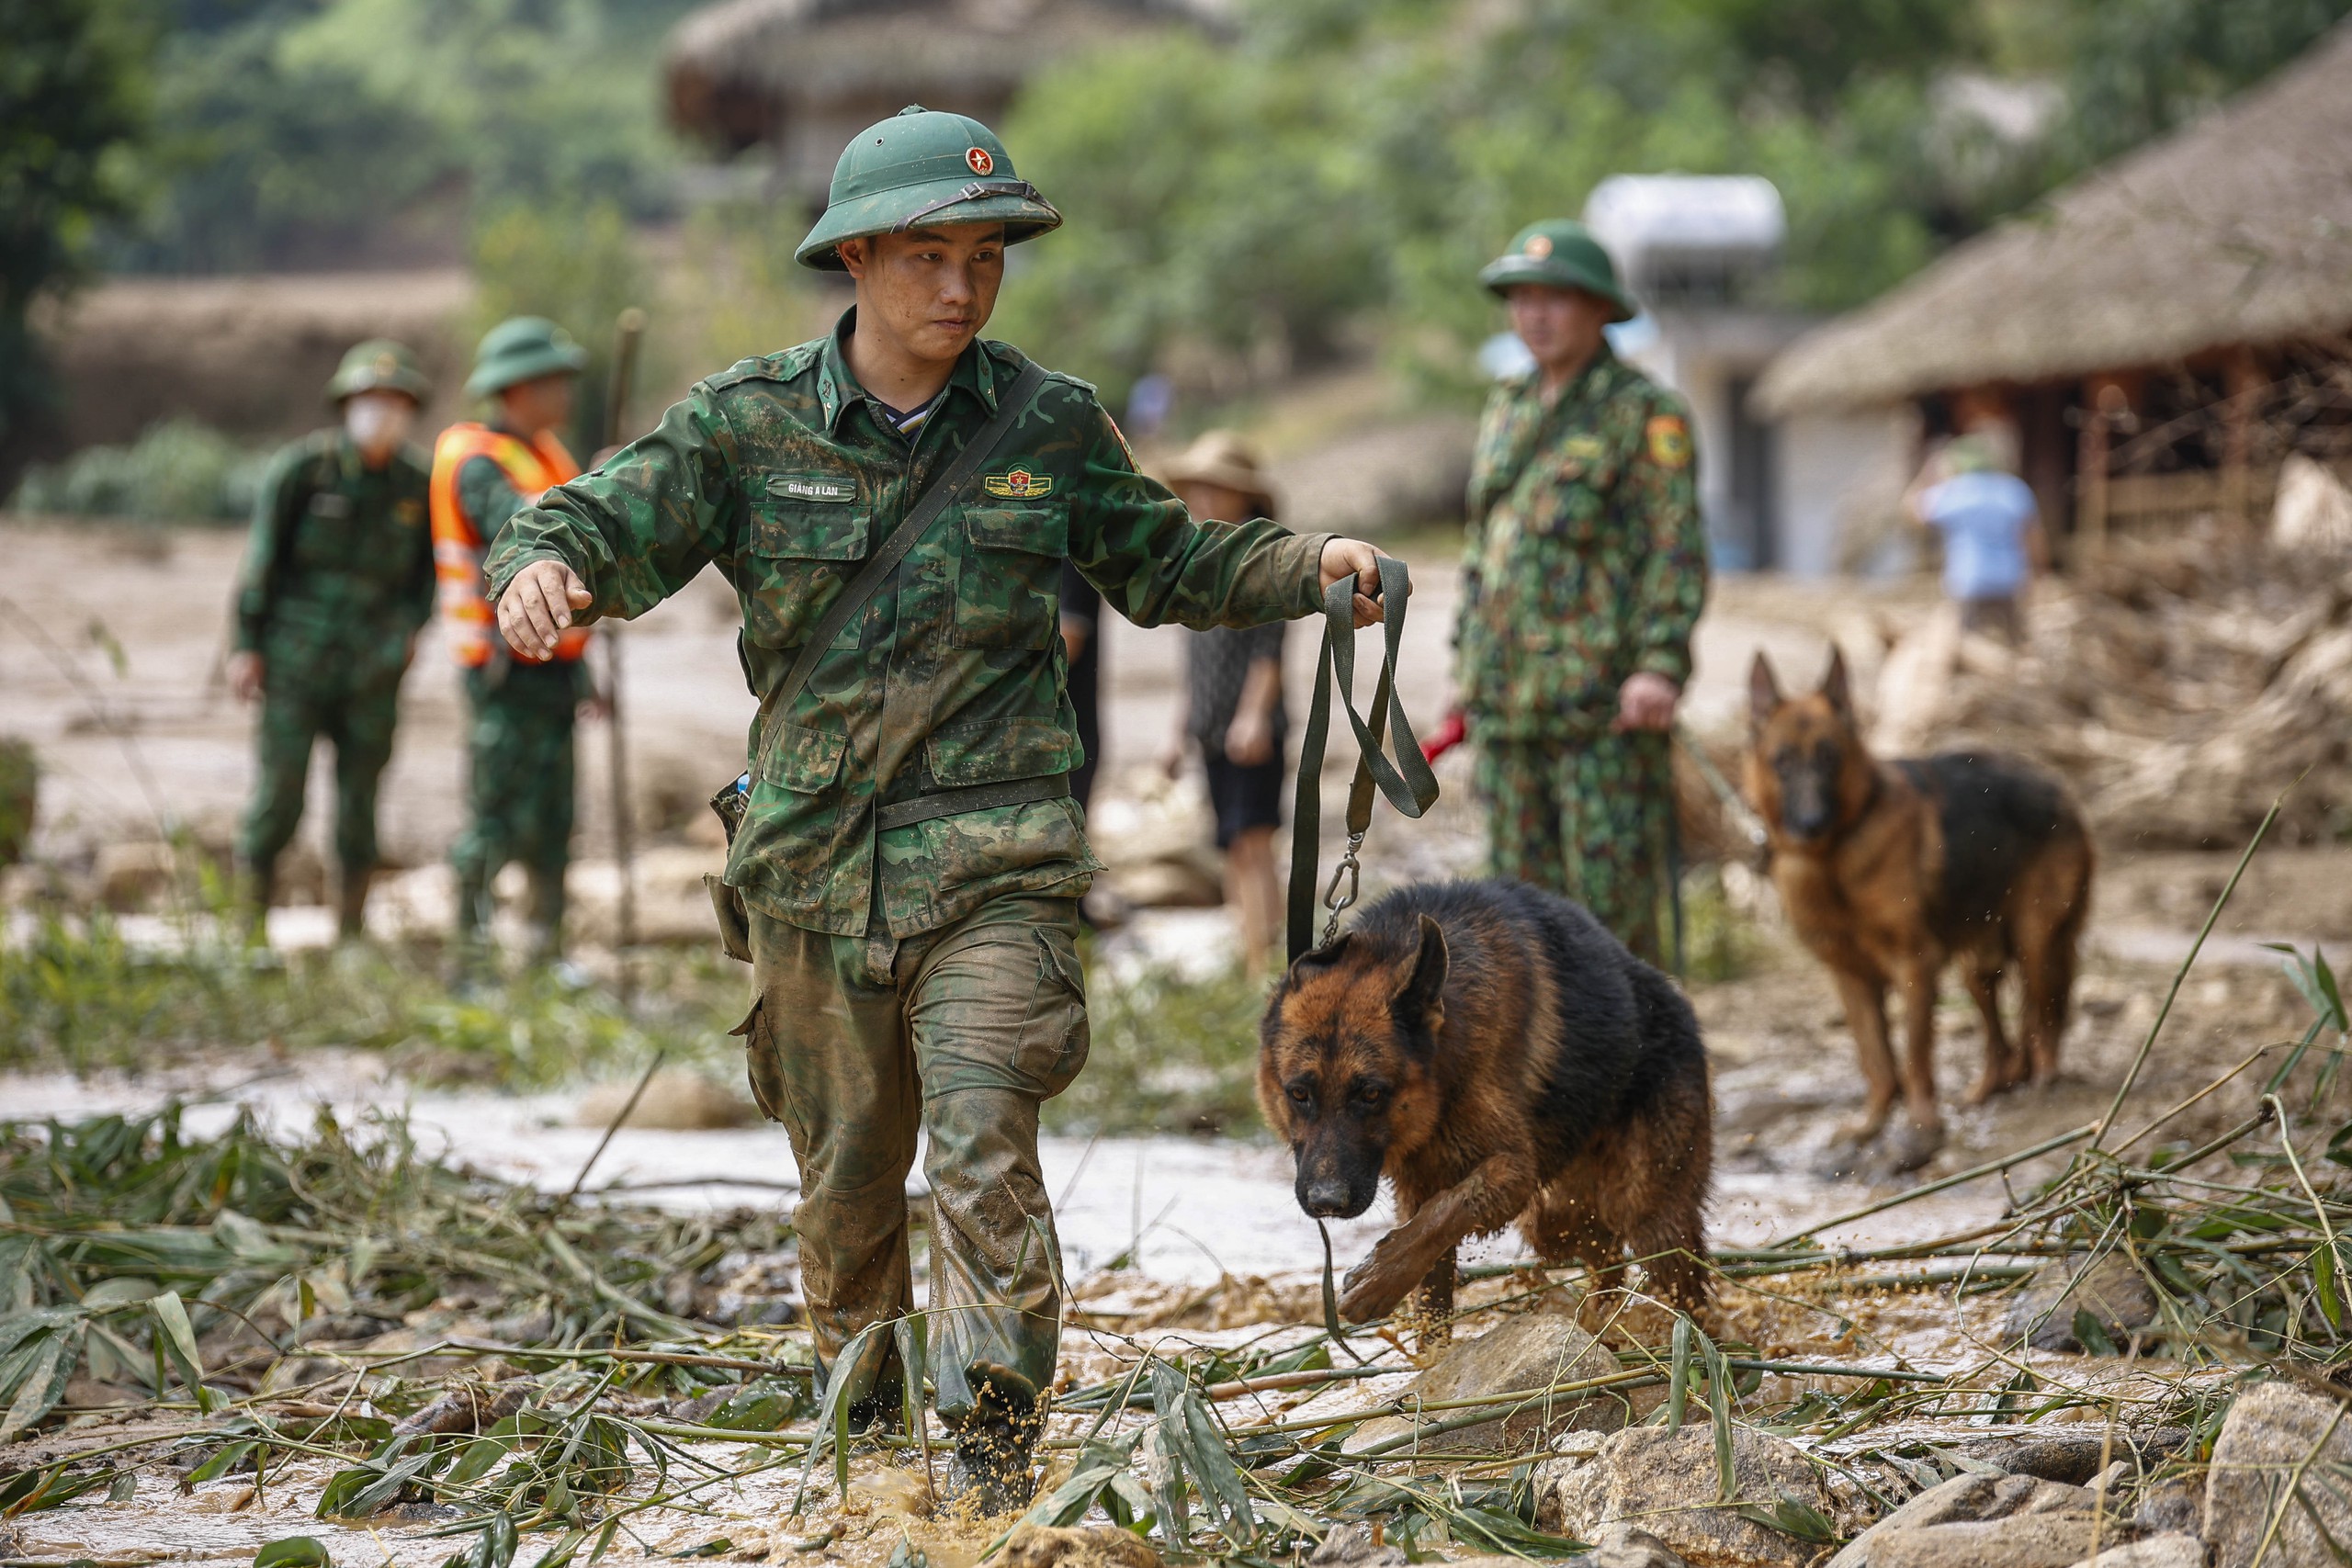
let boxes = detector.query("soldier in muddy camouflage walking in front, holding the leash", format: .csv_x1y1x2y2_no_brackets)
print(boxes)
489,108,1378,1512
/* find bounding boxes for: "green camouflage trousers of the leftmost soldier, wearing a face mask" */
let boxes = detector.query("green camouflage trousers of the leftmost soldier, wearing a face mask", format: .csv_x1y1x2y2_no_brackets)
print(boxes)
238,660,402,879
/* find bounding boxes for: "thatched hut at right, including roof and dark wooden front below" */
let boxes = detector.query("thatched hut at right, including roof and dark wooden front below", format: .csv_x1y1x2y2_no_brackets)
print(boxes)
1752,24,2352,541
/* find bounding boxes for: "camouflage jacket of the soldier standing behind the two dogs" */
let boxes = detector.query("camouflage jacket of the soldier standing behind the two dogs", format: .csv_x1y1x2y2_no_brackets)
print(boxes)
1453,348,1708,740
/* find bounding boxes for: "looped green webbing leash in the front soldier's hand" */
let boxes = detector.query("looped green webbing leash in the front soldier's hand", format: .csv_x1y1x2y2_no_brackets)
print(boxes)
1286,555,1437,964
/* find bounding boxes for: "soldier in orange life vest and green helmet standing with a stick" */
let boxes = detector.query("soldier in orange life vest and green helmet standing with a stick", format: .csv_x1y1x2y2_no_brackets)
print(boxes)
433,315,595,962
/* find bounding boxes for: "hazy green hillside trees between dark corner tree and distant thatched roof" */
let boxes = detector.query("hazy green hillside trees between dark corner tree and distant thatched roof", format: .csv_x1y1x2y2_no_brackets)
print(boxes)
113,0,692,270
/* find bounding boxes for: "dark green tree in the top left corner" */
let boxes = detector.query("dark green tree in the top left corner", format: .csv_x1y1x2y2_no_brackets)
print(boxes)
0,0,148,446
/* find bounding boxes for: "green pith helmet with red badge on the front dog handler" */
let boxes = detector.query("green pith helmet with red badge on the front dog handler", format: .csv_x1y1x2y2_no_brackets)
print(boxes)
795,104,1061,273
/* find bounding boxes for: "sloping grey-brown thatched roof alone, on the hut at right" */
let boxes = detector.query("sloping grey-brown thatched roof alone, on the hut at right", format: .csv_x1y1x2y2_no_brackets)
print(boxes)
1755,26,2352,413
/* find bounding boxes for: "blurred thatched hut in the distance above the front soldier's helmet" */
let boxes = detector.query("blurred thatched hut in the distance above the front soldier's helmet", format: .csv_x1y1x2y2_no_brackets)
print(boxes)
663,0,1223,197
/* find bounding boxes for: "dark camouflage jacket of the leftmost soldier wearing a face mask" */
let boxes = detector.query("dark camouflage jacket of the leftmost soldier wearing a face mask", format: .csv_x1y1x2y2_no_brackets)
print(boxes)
235,430,433,680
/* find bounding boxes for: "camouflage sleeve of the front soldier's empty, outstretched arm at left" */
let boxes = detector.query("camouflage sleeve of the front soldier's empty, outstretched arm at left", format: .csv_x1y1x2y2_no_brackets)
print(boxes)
489,386,741,621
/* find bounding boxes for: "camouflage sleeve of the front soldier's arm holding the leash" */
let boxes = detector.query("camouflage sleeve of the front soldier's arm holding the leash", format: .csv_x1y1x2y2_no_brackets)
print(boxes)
1063,383,1331,627
